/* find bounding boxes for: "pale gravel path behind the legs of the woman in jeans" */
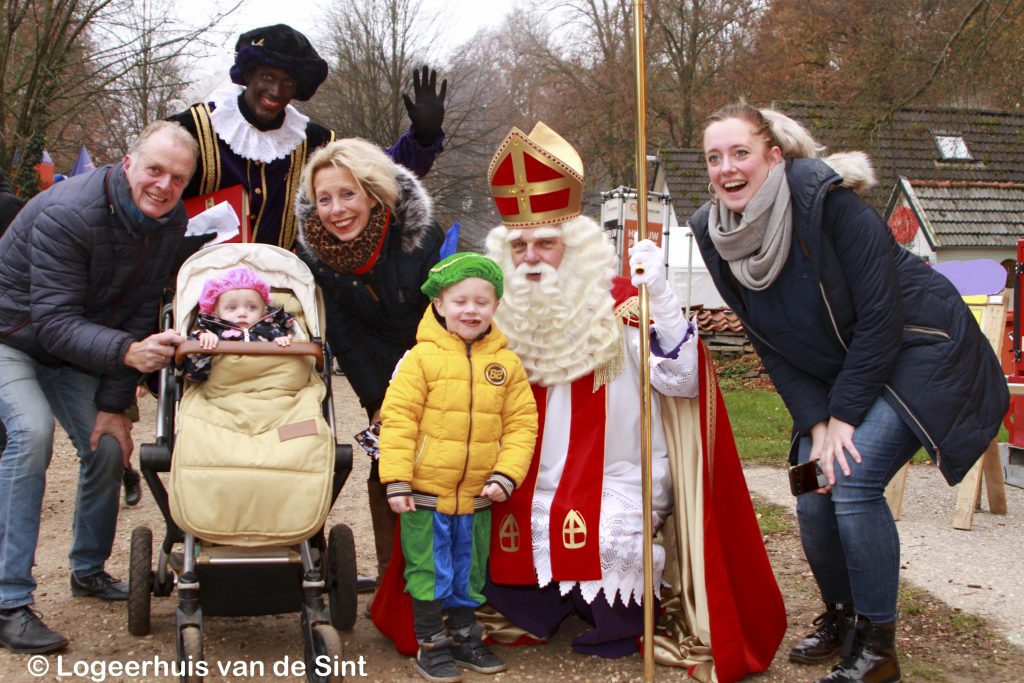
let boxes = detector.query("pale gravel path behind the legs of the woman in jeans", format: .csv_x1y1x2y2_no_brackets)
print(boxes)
743,465,1024,645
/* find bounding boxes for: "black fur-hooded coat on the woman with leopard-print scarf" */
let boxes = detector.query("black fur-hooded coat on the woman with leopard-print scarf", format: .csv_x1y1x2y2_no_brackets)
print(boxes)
296,167,444,415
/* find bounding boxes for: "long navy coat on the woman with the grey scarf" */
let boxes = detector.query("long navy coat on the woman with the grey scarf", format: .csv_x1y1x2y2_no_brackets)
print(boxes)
689,159,1010,485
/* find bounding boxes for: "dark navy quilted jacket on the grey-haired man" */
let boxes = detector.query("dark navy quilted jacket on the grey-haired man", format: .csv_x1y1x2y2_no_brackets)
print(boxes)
0,166,187,413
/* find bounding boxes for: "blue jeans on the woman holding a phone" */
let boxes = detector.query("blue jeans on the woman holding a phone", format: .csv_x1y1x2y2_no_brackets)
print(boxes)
797,398,921,624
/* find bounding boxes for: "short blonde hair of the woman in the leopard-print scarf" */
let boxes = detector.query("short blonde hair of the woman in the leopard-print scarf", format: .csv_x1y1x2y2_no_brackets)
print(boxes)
300,137,399,211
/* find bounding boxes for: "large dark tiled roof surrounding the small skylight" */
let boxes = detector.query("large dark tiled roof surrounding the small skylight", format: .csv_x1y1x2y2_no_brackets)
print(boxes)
773,100,1024,211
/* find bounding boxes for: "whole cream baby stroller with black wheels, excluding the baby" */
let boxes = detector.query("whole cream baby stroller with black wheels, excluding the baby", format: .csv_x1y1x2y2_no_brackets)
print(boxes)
128,244,356,681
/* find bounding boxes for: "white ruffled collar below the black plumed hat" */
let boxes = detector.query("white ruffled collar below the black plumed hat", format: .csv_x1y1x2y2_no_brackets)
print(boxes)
210,92,309,164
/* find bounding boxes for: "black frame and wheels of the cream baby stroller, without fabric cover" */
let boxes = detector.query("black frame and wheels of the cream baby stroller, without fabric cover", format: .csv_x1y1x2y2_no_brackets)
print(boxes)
127,245,357,683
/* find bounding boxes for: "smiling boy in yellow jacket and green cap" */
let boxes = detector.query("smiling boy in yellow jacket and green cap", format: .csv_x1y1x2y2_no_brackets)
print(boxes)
380,253,537,683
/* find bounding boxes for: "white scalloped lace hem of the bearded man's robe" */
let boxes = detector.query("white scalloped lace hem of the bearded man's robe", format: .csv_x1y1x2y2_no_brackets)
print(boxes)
530,488,665,606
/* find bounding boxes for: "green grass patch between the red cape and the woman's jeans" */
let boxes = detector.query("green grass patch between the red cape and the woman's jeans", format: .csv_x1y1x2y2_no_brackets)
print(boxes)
723,389,793,465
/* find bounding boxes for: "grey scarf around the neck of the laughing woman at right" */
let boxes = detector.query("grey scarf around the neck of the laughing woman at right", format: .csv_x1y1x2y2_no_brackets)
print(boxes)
708,164,793,291
